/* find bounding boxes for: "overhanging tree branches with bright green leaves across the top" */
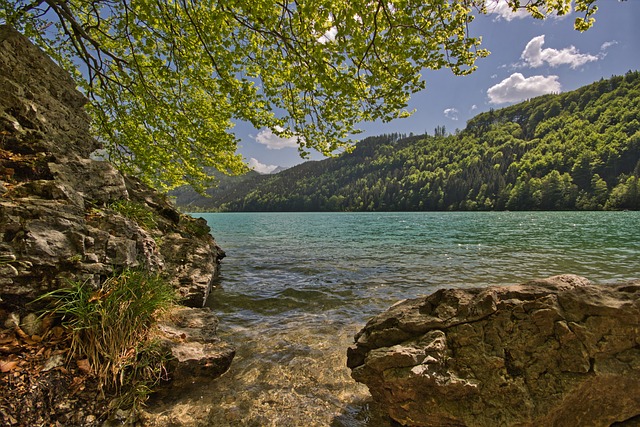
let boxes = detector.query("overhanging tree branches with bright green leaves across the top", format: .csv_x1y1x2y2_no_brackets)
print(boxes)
0,0,596,188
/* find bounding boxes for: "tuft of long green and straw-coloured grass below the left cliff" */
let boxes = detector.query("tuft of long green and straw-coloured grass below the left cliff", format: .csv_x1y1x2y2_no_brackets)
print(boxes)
41,270,176,407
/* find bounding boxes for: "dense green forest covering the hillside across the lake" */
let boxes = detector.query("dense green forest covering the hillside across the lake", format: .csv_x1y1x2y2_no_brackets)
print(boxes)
173,72,640,211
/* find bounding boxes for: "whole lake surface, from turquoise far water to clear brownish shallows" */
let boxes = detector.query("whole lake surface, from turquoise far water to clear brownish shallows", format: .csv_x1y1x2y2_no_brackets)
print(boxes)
180,212,640,426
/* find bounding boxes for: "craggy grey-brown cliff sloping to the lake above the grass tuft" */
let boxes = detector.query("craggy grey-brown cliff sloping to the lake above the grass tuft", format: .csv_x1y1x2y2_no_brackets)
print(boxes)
0,26,224,307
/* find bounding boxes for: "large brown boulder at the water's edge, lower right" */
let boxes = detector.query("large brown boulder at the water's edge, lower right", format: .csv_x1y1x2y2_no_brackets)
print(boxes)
347,275,640,427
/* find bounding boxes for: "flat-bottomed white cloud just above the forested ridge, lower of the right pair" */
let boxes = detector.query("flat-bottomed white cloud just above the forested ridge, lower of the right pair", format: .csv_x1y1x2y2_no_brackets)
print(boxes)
487,73,561,104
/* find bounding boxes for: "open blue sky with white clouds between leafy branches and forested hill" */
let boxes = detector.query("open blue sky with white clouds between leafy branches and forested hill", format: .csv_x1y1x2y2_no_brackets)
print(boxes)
234,0,640,173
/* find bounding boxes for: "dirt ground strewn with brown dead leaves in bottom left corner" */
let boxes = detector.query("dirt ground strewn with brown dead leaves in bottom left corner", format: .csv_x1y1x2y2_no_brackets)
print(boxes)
0,316,113,427
